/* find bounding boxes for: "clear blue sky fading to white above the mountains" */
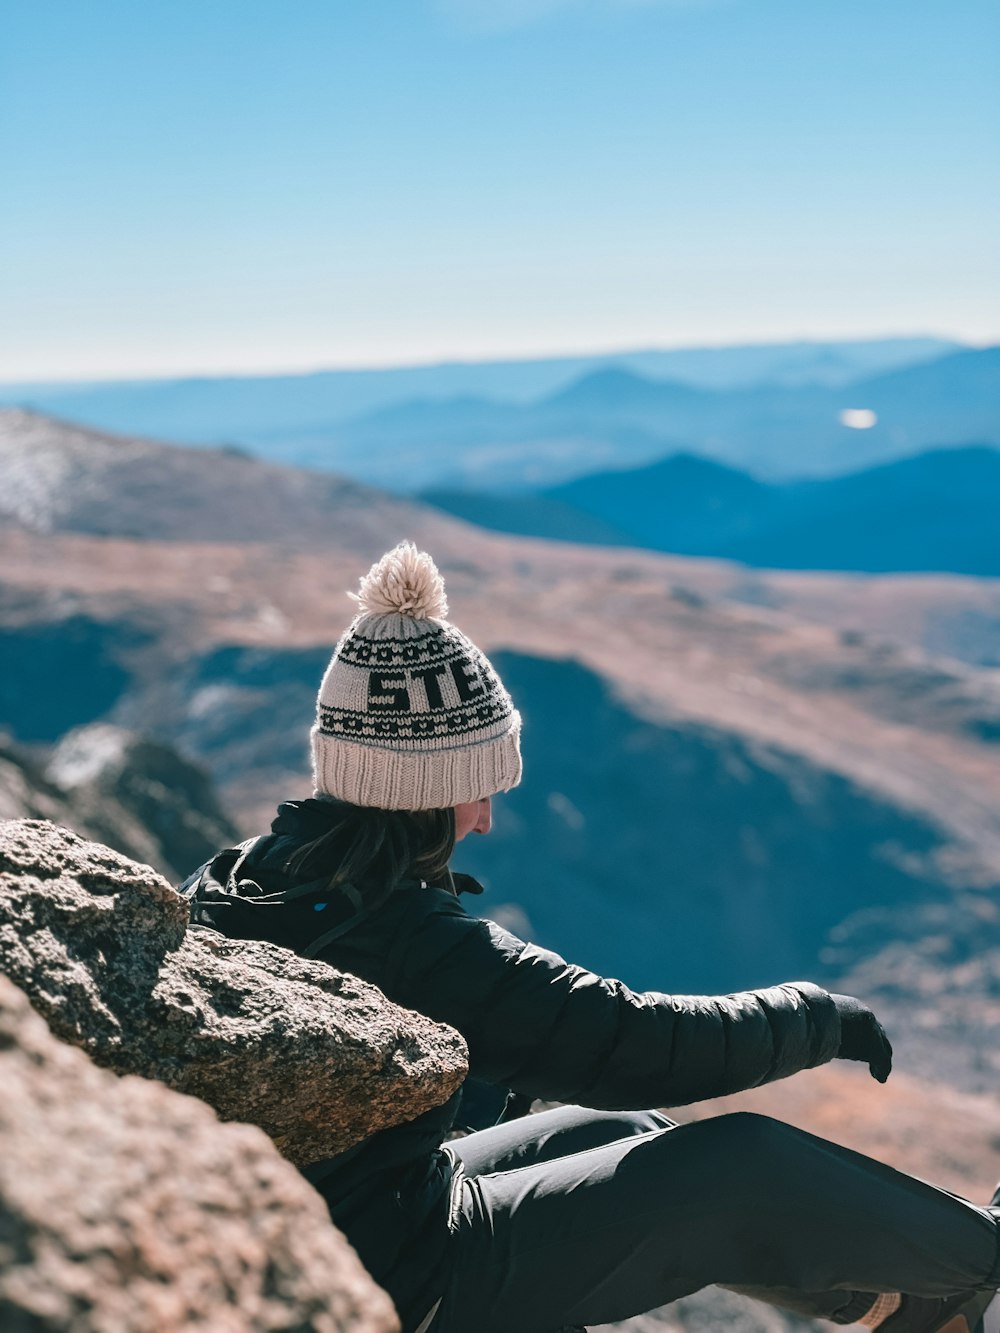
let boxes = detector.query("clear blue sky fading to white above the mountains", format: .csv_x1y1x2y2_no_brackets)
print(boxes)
0,0,1000,381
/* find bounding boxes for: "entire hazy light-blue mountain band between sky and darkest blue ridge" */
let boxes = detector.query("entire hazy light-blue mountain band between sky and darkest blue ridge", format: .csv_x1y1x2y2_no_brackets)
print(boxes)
0,340,1000,492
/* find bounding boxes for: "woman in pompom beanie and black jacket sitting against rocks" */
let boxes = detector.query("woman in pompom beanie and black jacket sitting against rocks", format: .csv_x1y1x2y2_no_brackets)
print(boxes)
184,544,1000,1333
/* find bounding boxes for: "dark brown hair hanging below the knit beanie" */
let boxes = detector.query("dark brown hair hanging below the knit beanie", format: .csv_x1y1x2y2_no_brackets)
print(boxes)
285,801,455,906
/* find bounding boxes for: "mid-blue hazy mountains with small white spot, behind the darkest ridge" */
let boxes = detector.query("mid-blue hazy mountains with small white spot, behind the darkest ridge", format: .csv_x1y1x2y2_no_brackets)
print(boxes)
349,348,1000,492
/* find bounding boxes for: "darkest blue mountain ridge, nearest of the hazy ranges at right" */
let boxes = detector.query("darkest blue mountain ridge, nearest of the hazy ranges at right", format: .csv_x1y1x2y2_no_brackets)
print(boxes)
421,445,1000,577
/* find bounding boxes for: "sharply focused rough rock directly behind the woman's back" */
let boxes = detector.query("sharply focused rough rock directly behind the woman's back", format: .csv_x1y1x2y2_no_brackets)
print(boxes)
0,820,467,1165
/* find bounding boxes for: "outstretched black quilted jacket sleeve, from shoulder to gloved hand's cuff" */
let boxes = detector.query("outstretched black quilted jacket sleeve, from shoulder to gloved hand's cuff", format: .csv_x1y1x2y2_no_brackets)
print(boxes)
392,894,840,1110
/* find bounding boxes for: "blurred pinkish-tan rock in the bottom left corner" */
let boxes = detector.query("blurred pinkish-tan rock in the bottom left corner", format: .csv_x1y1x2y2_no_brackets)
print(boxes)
0,977,399,1333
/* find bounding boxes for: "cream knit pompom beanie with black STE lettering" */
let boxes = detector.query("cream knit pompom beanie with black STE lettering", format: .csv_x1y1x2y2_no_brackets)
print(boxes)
311,543,521,810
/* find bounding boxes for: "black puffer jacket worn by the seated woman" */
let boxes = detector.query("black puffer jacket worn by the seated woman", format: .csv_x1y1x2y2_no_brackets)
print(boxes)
188,800,840,1327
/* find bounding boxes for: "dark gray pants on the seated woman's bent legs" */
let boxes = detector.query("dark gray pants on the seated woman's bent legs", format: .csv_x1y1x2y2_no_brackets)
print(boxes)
432,1106,1000,1333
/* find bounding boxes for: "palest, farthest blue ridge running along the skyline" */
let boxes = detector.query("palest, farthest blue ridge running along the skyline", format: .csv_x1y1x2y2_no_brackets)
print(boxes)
0,337,957,450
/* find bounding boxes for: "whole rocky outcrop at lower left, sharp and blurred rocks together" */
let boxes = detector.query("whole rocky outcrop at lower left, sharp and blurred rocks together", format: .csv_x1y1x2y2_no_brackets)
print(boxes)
0,820,467,1333
